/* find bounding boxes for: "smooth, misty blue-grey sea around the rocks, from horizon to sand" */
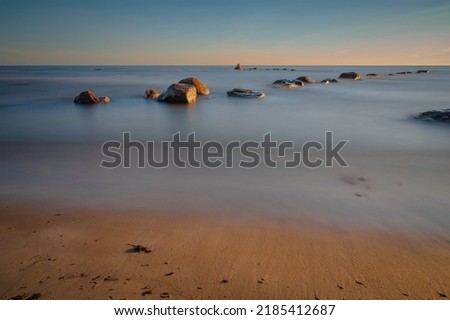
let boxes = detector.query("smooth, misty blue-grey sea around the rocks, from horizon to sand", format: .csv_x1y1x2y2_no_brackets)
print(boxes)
0,66,450,235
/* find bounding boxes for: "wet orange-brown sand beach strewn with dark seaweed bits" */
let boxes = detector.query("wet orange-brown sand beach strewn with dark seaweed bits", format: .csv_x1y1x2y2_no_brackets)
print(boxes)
0,202,450,299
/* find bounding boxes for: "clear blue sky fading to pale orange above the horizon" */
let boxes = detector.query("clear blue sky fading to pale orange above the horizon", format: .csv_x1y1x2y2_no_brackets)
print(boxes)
0,0,450,65
